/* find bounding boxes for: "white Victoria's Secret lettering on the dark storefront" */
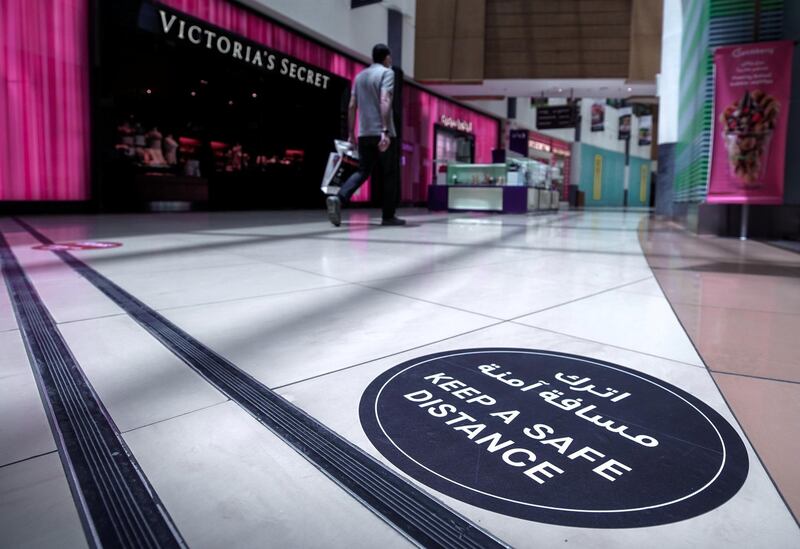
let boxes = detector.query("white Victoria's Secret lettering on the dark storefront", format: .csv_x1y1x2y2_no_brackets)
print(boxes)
152,7,331,90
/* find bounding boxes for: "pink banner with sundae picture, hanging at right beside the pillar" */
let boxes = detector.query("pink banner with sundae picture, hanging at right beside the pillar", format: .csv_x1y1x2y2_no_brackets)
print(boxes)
707,41,793,204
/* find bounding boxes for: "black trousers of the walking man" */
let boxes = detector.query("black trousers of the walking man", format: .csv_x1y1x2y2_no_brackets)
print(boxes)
339,135,400,219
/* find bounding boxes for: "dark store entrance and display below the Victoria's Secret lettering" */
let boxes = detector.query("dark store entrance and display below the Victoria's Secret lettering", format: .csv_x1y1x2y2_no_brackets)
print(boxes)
96,2,348,210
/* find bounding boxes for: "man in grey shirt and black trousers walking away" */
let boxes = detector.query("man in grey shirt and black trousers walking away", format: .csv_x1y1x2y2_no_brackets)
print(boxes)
327,44,406,227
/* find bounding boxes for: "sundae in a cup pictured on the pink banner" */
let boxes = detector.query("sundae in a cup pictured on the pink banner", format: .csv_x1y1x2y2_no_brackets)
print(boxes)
720,89,780,188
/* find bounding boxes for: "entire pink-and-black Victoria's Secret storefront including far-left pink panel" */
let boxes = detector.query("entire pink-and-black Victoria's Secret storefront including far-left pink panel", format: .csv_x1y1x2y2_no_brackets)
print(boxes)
0,0,499,209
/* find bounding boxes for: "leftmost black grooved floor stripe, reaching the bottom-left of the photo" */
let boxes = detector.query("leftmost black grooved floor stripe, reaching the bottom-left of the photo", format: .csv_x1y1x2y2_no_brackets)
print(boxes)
0,234,185,548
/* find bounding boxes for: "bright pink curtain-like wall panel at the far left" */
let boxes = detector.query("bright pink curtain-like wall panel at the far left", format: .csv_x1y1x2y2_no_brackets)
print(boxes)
0,0,89,200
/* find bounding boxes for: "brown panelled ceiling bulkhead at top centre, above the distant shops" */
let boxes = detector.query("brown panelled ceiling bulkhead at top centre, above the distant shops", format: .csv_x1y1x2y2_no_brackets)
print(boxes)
414,0,662,97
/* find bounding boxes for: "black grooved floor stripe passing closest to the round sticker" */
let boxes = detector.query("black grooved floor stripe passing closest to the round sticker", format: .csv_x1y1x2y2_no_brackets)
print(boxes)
16,219,506,549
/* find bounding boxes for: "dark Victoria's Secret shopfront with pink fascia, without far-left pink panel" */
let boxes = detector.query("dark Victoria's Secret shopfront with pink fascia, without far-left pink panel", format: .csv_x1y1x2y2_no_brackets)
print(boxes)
93,0,499,209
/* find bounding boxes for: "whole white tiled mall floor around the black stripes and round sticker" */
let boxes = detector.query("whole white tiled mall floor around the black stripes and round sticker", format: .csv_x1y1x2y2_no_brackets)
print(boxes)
0,211,800,548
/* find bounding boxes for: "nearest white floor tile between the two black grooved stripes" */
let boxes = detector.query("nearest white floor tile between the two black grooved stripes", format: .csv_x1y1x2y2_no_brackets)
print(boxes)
125,403,409,549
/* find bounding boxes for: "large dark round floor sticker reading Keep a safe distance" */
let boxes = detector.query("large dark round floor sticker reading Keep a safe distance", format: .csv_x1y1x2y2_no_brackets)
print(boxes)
360,349,748,528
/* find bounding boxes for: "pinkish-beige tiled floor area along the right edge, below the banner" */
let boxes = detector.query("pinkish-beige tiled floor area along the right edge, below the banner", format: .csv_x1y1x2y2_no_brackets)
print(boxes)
642,221,800,517
